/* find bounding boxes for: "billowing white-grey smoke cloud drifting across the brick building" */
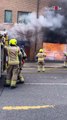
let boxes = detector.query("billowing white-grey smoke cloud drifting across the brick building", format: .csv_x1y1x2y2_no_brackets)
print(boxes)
8,10,64,40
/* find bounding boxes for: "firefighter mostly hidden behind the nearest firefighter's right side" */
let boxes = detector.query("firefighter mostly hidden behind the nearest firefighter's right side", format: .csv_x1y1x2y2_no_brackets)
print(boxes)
17,48,27,83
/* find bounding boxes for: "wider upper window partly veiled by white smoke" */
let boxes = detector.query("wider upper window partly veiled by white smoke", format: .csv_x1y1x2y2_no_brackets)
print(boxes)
17,11,29,24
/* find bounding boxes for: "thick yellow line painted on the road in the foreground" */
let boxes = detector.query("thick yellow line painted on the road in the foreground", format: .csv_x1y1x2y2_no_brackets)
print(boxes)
2,105,54,110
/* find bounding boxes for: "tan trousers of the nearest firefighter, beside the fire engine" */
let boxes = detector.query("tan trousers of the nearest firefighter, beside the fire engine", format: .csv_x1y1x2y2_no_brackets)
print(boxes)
6,65,18,87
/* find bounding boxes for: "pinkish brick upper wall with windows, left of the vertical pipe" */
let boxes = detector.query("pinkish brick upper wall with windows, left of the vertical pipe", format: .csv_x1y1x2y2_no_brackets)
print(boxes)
0,0,36,28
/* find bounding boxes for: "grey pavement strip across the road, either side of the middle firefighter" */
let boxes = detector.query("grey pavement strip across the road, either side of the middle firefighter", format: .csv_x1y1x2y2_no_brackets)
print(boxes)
22,61,66,74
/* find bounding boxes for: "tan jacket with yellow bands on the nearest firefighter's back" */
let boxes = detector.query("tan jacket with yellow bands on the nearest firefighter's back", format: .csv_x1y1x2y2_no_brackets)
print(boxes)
6,46,21,65
